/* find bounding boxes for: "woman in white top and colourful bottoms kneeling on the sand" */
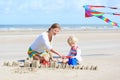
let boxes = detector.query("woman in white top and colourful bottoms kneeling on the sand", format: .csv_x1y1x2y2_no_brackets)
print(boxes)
28,23,61,63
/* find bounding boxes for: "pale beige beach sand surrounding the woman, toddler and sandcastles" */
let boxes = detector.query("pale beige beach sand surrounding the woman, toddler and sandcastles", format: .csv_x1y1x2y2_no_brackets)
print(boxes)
0,30,120,80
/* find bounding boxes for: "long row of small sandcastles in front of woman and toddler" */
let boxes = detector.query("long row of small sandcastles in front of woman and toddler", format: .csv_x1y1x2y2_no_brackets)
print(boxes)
3,58,98,73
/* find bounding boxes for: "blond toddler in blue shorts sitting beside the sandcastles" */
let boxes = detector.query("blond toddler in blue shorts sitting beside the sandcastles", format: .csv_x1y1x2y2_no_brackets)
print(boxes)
63,36,82,65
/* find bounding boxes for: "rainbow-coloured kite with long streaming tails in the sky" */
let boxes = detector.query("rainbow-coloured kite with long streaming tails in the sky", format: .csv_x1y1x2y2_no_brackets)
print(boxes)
83,5,120,27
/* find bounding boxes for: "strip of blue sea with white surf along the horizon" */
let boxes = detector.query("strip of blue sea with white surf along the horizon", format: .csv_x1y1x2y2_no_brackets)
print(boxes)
0,24,120,31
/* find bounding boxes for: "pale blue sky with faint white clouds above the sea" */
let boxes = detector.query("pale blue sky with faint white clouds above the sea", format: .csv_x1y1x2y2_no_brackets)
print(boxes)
0,0,120,25
